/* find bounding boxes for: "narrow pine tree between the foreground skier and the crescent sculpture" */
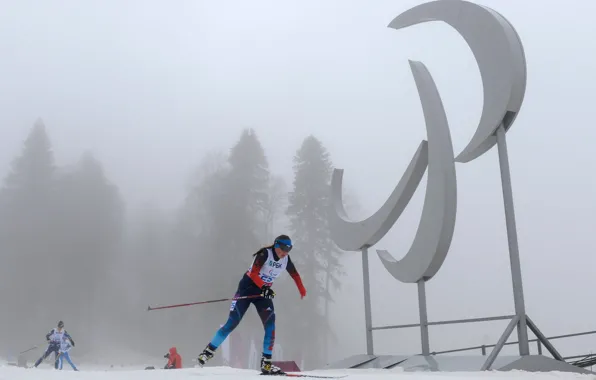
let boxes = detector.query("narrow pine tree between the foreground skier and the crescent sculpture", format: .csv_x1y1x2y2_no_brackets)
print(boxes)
284,136,343,367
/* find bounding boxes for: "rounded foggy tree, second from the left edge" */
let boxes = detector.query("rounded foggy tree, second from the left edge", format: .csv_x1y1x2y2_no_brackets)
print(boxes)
50,154,124,350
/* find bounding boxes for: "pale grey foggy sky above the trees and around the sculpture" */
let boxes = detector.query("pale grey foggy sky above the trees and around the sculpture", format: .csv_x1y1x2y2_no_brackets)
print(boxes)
0,0,596,366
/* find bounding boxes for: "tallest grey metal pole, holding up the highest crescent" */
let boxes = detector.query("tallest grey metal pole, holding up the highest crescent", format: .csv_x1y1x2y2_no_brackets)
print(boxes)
497,124,530,356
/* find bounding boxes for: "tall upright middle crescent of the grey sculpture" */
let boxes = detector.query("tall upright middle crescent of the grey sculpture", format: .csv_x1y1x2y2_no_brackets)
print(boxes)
377,61,457,283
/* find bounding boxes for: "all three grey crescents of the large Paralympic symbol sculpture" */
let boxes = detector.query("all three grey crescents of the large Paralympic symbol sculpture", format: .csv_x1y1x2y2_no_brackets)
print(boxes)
329,0,527,282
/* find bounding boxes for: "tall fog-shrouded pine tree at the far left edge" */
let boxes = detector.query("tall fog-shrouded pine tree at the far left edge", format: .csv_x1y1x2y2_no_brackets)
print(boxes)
0,119,55,345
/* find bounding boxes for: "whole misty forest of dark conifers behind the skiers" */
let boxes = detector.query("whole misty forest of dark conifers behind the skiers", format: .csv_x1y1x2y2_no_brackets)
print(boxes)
0,119,356,368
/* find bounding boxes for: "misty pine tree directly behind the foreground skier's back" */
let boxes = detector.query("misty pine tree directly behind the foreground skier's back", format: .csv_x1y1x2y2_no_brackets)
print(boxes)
178,129,270,363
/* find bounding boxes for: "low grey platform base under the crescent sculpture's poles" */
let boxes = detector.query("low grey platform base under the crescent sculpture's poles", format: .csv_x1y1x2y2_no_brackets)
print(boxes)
325,355,595,374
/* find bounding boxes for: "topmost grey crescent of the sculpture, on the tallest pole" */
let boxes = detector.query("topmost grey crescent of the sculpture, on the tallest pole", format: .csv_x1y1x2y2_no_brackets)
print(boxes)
389,0,527,162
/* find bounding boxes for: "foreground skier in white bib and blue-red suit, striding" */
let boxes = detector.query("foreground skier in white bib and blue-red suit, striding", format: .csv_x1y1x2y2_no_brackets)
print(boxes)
197,235,306,375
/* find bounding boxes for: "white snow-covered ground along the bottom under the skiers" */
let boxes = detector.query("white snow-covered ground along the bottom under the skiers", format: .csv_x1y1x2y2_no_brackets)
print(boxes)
0,365,595,380
